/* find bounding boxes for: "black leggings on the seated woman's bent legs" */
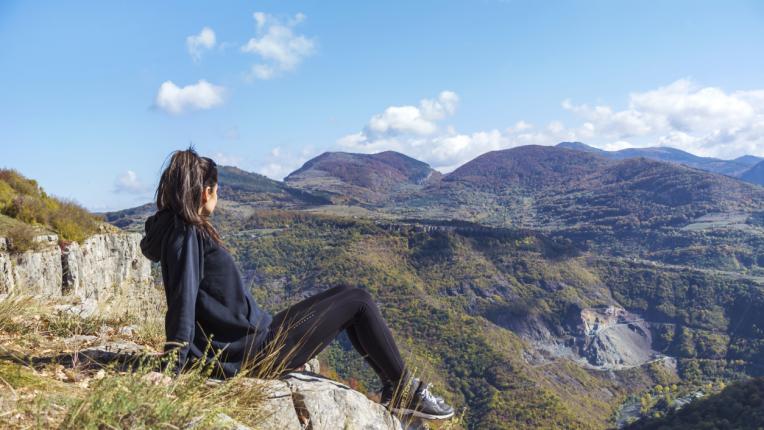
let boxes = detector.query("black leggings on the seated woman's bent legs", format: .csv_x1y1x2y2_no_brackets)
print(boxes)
251,285,404,382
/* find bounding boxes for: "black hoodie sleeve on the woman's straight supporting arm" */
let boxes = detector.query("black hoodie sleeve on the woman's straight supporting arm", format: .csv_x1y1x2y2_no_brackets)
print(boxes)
164,225,203,371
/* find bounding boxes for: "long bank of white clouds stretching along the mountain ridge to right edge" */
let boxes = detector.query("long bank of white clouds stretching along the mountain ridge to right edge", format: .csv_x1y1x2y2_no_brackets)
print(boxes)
336,79,764,172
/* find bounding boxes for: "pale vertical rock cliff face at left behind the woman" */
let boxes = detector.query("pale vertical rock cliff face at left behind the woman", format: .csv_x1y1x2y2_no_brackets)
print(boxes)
0,233,152,301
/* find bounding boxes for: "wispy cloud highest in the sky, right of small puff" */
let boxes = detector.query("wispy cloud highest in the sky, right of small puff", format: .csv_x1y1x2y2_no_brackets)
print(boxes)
241,12,316,79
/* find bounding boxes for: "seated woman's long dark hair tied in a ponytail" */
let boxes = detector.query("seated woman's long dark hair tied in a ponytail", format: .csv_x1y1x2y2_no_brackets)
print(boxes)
155,144,225,247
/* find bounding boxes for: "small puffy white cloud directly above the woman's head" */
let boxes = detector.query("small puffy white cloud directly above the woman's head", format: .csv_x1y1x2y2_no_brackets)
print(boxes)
156,79,225,115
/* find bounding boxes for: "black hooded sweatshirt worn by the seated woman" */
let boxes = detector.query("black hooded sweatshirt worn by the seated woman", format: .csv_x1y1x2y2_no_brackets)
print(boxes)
141,208,271,376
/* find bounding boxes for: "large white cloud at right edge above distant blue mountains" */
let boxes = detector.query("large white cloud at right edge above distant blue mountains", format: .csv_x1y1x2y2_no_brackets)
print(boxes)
562,79,764,158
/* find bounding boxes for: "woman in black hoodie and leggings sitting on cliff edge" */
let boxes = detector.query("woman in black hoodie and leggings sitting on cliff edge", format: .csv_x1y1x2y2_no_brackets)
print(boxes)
141,147,454,419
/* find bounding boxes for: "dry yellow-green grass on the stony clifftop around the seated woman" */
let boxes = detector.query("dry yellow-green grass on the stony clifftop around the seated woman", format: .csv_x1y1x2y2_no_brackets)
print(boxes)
0,295,463,430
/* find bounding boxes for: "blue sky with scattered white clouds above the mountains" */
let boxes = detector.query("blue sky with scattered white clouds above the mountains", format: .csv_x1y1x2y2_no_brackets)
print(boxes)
0,0,764,211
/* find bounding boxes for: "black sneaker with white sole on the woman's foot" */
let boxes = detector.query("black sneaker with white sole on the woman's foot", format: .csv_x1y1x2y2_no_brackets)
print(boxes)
381,378,454,420
